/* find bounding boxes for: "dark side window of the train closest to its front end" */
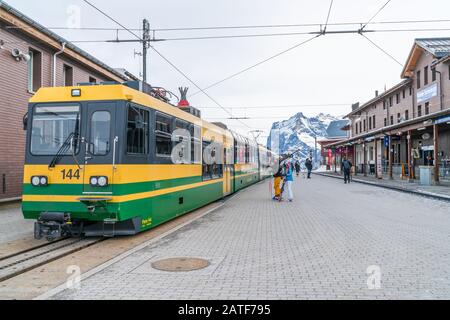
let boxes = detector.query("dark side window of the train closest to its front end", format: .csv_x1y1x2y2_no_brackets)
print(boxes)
127,105,149,154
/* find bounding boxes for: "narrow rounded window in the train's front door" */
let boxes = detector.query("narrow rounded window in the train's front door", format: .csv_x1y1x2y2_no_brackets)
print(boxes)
89,111,111,156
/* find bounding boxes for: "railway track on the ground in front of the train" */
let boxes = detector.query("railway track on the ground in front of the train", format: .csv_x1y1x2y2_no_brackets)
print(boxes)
0,238,105,282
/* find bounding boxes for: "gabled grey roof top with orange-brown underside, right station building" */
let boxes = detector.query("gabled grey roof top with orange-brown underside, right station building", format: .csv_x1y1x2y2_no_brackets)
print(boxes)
402,38,450,78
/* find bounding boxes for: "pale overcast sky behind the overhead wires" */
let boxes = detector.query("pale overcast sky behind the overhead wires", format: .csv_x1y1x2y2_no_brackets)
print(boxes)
6,0,450,140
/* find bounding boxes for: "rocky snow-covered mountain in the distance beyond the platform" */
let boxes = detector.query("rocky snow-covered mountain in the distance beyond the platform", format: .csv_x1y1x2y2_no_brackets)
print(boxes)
267,112,338,166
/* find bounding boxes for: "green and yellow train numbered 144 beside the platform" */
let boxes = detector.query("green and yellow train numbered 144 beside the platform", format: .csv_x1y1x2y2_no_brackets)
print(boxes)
22,82,277,240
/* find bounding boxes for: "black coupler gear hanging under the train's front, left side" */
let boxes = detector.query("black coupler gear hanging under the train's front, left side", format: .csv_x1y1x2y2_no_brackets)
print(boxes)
34,212,72,241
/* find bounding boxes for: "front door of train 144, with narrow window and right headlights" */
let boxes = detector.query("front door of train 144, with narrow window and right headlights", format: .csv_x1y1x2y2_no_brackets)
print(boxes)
83,103,118,195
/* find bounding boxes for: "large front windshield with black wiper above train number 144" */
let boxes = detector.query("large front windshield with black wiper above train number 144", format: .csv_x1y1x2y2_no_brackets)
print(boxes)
31,106,80,156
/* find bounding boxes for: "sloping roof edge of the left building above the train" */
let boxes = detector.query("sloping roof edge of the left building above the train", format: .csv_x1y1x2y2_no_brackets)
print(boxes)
0,1,134,81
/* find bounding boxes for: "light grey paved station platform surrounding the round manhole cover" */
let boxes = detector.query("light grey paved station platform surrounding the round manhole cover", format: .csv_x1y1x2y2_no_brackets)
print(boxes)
39,176,450,300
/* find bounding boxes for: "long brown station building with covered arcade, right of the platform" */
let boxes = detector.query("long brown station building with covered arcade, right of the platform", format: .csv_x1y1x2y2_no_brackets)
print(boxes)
327,38,450,184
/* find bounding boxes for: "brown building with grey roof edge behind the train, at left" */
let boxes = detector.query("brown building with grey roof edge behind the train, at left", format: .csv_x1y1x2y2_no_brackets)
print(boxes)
0,1,135,202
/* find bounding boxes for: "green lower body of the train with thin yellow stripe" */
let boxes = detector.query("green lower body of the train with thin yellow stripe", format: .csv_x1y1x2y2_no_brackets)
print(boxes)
22,171,267,241
